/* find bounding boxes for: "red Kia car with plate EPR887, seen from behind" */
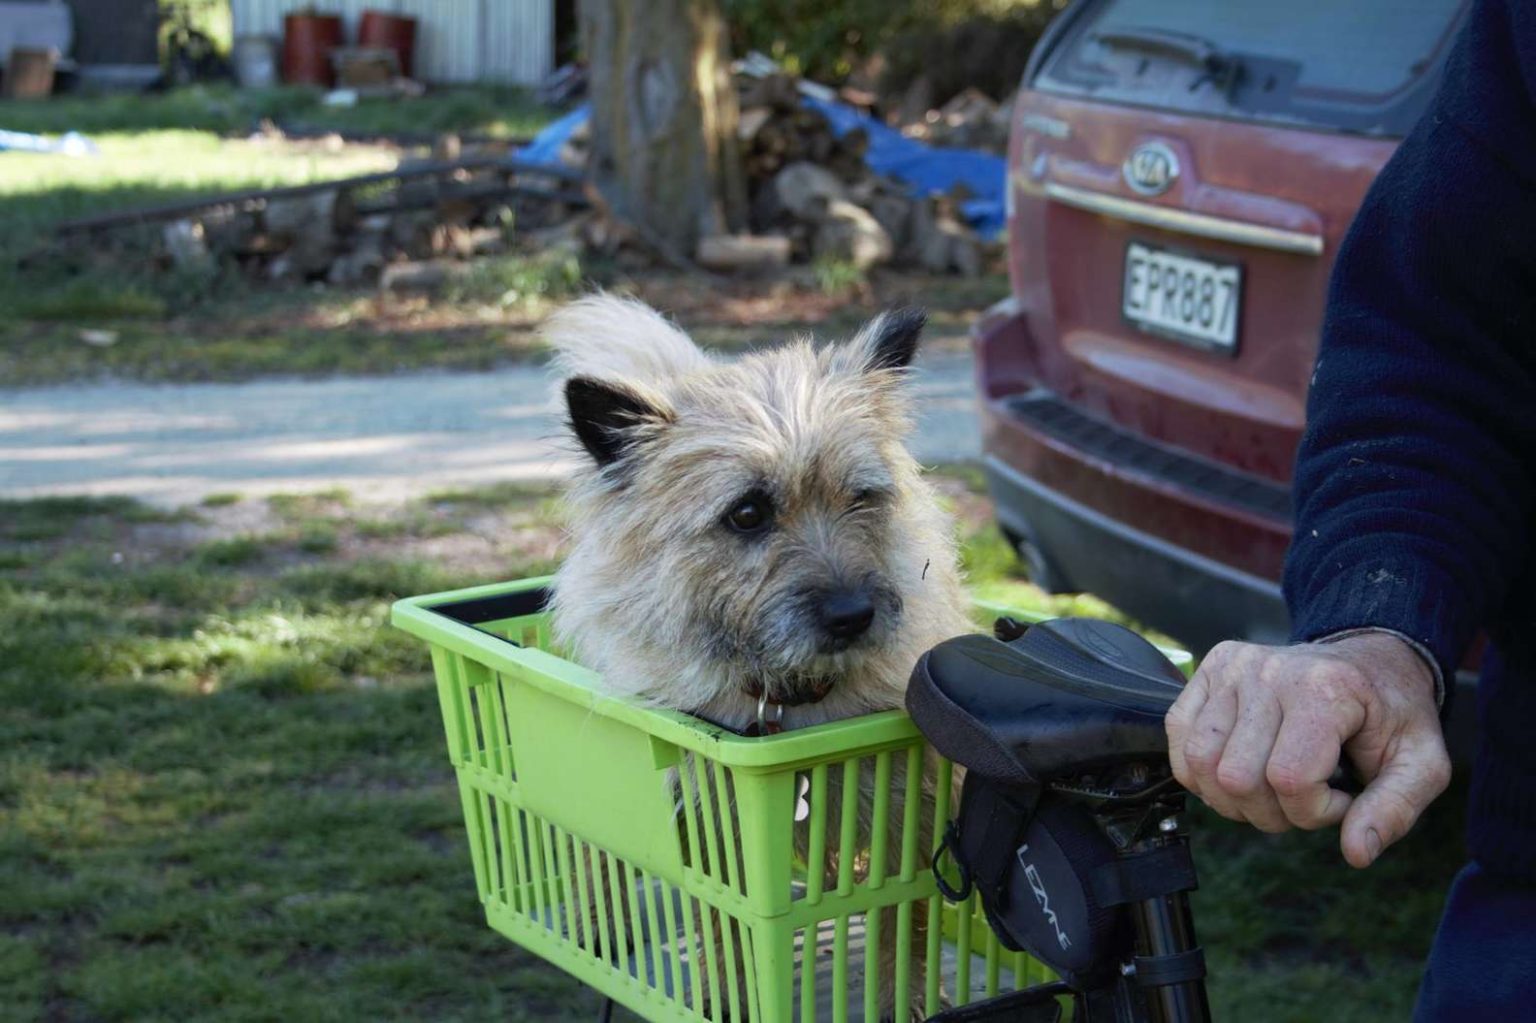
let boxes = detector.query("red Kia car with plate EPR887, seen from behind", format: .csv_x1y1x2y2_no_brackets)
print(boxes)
974,0,1467,650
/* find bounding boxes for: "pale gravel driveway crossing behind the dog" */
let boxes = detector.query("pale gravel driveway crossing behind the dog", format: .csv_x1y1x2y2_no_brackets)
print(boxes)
0,346,980,504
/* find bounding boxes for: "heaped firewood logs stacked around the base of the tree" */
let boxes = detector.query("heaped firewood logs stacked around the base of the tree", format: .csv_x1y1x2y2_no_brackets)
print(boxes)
42,63,1008,290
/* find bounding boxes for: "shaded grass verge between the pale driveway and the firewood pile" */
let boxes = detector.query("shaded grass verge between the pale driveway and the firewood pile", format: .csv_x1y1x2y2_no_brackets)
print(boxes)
0,262,1008,386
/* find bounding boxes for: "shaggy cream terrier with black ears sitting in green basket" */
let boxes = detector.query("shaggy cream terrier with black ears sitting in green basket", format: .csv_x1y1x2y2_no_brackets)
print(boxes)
545,295,974,1018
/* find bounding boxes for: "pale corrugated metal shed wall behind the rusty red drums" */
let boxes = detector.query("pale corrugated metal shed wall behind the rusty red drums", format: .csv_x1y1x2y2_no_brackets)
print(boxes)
230,0,554,84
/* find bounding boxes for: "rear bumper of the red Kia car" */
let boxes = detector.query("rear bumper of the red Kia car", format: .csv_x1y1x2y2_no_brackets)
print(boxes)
974,294,1290,650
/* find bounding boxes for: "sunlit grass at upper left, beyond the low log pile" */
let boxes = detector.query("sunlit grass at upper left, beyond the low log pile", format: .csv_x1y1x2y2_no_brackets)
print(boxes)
0,88,553,337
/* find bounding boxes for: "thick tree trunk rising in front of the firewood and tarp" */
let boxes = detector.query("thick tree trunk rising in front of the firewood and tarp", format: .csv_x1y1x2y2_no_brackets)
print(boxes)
581,0,746,257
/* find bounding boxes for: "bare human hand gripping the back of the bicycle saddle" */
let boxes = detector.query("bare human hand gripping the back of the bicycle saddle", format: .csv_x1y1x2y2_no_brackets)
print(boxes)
1166,633,1450,866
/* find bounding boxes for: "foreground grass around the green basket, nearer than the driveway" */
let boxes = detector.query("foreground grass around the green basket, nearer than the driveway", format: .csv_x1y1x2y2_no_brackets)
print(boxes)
0,470,1464,1021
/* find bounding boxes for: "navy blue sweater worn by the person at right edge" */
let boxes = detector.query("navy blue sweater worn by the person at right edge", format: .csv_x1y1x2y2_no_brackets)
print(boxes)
1286,0,1536,880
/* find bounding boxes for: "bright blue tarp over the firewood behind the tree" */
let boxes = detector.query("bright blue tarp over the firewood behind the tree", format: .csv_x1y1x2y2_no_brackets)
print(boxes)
518,95,1008,237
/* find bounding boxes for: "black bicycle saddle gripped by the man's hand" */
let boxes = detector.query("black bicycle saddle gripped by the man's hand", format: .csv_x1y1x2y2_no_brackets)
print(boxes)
906,617,1184,785
